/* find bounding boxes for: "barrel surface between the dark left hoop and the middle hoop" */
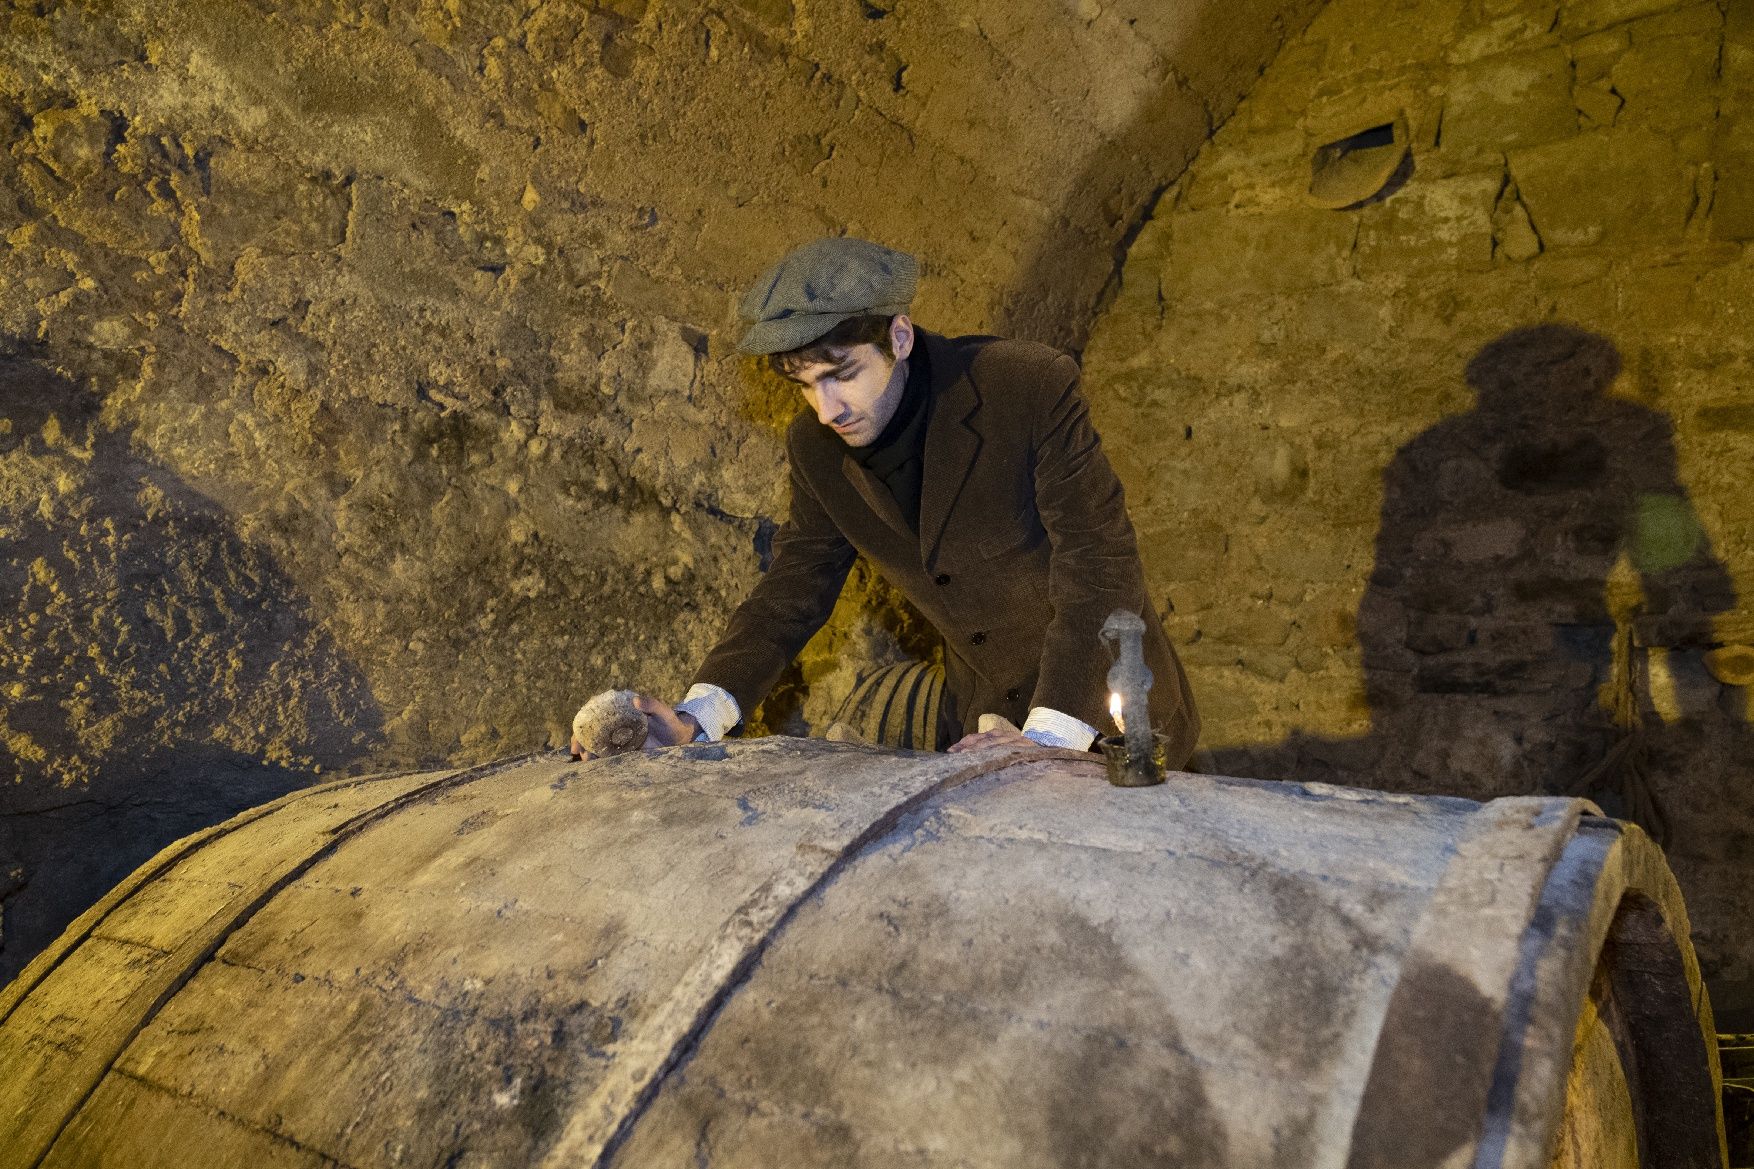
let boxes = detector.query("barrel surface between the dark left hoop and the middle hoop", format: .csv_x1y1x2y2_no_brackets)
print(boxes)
30,748,1003,1165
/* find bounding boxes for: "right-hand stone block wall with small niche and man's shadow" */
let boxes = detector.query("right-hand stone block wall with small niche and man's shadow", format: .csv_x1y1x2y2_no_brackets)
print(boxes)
1086,0,1754,1006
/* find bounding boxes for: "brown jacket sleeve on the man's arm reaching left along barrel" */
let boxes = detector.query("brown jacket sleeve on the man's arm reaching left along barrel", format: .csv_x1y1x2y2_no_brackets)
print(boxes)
695,428,858,718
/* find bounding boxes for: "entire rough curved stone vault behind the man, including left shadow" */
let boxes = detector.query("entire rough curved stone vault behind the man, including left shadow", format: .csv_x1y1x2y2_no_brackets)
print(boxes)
0,0,1317,978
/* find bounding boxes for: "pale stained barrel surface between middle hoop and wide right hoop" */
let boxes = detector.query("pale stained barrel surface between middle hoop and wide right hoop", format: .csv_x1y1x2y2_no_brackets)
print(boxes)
614,762,1477,1169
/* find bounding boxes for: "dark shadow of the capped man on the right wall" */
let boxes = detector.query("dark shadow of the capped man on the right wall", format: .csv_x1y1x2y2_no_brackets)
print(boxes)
1207,325,1747,841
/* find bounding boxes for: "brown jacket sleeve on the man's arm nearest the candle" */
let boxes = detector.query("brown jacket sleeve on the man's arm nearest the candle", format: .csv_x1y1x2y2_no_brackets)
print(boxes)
1031,356,1177,727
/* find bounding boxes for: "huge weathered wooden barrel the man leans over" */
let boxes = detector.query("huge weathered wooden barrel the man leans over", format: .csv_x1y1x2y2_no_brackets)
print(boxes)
0,739,1722,1169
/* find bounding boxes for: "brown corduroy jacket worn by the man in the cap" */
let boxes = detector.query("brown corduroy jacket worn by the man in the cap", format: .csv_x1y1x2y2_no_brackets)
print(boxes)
695,330,1200,767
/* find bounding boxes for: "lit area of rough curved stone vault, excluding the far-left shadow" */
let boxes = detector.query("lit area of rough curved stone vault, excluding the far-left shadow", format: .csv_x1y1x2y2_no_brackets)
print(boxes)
0,0,1312,772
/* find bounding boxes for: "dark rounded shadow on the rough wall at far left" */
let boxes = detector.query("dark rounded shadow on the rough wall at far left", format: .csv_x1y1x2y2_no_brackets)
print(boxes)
0,339,381,985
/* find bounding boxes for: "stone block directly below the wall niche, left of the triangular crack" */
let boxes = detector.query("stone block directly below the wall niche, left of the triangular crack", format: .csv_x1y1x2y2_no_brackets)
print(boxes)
1358,174,1503,279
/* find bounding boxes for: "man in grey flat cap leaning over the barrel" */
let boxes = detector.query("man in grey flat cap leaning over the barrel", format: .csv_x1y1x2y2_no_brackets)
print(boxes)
574,239,1200,754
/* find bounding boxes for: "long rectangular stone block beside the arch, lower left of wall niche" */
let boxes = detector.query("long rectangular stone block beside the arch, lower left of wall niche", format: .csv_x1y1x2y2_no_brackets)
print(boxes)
1163,209,1358,302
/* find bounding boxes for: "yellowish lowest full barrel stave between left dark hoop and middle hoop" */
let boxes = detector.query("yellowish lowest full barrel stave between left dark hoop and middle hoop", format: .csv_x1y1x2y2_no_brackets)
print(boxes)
118,957,589,1167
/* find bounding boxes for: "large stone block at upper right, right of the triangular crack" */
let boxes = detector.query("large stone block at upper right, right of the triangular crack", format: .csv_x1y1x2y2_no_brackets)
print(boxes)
1510,128,1693,247
